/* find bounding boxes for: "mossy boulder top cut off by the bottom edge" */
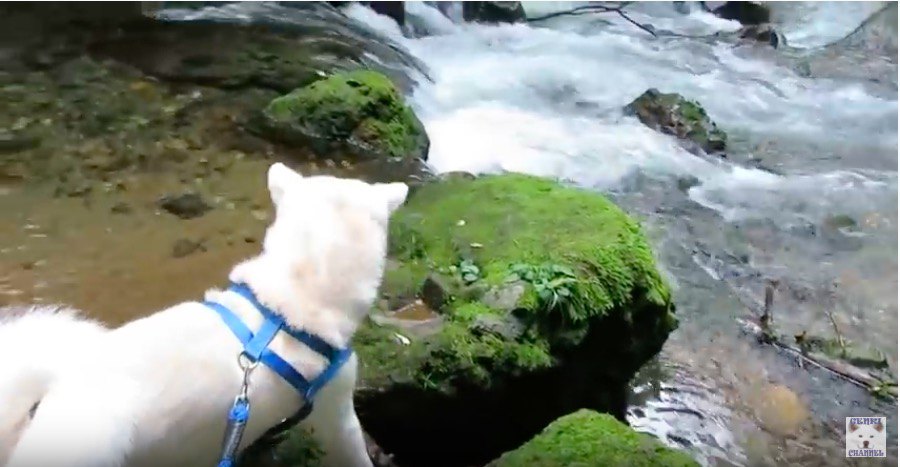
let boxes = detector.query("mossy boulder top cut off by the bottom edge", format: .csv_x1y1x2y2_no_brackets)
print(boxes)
488,410,700,467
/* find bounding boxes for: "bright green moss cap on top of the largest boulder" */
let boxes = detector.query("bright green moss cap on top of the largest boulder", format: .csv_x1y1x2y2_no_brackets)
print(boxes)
391,174,671,323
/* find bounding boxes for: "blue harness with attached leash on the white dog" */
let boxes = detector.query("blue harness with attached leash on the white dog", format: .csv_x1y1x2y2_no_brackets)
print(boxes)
203,284,353,467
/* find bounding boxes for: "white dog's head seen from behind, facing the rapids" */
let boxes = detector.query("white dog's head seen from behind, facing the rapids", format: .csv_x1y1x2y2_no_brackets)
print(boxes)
255,163,408,320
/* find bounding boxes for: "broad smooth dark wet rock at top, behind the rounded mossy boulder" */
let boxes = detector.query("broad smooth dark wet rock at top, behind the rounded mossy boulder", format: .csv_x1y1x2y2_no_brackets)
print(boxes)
91,2,428,92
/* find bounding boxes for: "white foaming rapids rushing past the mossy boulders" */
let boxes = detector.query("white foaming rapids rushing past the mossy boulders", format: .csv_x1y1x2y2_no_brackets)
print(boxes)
345,2,897,223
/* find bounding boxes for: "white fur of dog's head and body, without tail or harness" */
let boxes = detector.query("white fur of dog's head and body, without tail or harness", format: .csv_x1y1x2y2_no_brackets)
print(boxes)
8,164,407,467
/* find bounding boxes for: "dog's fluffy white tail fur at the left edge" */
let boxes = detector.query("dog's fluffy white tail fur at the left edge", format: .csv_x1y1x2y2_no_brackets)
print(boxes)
0,306,106,465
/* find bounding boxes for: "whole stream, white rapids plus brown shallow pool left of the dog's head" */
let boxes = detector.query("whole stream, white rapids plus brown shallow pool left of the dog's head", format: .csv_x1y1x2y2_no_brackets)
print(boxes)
0,2,898,466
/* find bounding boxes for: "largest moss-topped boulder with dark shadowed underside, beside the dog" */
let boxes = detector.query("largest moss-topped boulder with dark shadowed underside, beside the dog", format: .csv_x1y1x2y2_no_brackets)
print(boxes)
355,174,677,466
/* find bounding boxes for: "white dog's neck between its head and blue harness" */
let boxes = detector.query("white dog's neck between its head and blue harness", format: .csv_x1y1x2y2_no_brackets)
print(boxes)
229,253,364,348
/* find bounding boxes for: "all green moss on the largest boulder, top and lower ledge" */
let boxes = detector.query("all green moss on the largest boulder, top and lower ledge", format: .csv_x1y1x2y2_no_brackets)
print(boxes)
370,174,677,388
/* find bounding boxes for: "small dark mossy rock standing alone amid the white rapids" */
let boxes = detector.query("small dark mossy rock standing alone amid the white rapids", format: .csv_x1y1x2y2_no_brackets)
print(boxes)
625,89,728,154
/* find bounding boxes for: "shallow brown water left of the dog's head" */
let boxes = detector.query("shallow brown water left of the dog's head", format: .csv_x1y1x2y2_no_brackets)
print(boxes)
0,157,270,324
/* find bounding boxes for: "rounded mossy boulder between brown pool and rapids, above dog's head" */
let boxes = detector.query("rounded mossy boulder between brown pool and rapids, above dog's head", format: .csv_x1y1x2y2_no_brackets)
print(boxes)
260,70,429,160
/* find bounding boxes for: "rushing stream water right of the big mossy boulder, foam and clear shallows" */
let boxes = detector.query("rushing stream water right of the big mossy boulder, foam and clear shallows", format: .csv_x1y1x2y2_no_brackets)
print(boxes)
346,2,898,465
